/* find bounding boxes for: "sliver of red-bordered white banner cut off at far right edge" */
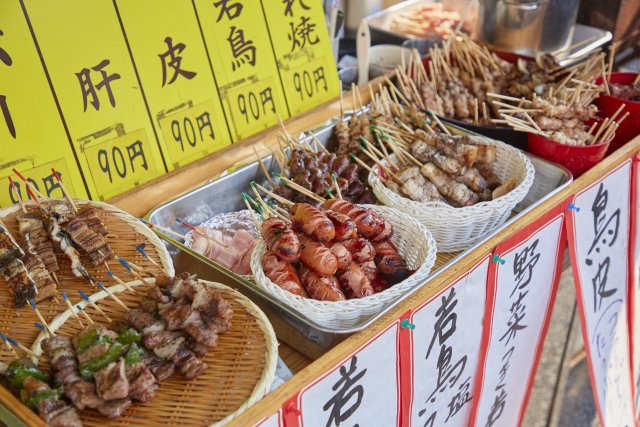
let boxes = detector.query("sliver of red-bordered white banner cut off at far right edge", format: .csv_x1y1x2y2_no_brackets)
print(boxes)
629,154,640,420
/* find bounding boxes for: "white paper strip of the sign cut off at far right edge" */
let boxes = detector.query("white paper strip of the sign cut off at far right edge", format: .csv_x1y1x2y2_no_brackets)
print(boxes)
632,160,640,419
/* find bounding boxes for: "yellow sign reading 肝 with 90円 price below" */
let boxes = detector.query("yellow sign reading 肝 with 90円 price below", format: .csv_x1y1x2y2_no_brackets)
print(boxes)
25,0,165,199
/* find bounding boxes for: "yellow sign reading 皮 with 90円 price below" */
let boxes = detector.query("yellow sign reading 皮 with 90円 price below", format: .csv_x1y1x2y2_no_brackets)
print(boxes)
116,0,231,170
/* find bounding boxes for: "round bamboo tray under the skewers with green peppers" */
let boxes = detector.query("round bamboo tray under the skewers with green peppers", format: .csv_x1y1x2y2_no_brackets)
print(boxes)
32,279,278,426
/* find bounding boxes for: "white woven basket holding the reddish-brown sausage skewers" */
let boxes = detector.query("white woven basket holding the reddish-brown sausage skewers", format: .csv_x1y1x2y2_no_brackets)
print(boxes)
251,205,436,328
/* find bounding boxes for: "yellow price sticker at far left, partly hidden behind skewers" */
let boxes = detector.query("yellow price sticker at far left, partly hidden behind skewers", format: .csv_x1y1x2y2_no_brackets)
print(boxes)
0,159,78,207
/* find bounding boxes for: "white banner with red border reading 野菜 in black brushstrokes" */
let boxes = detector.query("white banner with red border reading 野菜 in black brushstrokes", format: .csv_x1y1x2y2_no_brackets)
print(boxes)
471,206,564,427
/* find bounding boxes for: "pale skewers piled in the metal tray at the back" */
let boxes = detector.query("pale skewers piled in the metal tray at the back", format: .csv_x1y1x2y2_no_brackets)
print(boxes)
391,3,461,38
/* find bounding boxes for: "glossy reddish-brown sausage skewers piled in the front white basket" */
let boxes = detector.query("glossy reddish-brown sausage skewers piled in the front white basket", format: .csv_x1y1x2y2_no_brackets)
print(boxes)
243,182,411,301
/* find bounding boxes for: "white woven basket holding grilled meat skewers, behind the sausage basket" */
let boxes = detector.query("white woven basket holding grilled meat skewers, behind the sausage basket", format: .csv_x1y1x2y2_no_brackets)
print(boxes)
369,136,535,252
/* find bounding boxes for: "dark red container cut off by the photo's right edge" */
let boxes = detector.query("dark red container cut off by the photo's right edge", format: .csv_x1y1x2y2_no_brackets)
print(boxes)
594,73,640,154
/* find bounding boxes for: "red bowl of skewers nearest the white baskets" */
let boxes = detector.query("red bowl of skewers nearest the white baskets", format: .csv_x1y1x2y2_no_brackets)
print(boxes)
528,133,615,178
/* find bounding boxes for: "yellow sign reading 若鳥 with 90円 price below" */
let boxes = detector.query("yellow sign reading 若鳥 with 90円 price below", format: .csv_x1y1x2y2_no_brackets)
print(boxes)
195,0,289,139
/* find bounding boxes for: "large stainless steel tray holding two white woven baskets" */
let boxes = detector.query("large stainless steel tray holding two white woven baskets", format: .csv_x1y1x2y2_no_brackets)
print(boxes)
147,120,573,358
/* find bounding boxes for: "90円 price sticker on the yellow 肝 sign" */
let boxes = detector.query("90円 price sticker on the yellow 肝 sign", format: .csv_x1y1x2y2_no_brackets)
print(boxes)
84,129,158,200
